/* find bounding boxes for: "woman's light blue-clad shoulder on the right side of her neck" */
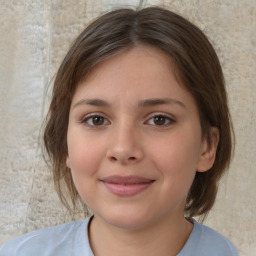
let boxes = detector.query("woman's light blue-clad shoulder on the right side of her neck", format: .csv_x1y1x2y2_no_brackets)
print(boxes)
179,220,238,256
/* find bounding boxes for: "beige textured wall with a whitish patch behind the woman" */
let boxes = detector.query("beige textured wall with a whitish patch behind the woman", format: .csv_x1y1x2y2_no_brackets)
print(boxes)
0,0,256,256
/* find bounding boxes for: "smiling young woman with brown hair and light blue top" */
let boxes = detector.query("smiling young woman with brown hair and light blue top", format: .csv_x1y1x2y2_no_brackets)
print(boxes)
0,7,238,256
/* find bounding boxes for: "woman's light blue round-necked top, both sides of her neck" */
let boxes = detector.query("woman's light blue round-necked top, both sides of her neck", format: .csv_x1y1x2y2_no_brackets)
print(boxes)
0,218,238,256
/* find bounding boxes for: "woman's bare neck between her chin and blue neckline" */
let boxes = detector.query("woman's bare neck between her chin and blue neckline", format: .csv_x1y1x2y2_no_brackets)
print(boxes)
89,216,193,256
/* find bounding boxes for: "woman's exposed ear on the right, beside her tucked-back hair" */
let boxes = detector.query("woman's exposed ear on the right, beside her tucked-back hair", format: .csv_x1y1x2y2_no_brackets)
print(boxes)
197,126,220,172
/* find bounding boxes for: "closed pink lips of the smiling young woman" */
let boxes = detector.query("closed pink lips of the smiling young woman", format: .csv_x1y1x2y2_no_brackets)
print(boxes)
100,175,155,196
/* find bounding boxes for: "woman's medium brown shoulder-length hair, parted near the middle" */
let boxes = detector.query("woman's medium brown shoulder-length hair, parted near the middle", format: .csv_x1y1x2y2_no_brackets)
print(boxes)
44,7,233,217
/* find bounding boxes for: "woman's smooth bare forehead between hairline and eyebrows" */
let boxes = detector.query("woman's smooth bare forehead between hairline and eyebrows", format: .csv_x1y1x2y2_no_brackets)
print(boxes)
74,45,190,98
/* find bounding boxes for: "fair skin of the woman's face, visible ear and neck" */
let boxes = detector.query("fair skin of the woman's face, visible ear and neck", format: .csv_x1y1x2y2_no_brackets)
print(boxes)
67,45,218,256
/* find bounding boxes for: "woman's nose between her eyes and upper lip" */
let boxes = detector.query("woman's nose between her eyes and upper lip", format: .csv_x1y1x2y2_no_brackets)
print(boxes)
107,124,144,165
